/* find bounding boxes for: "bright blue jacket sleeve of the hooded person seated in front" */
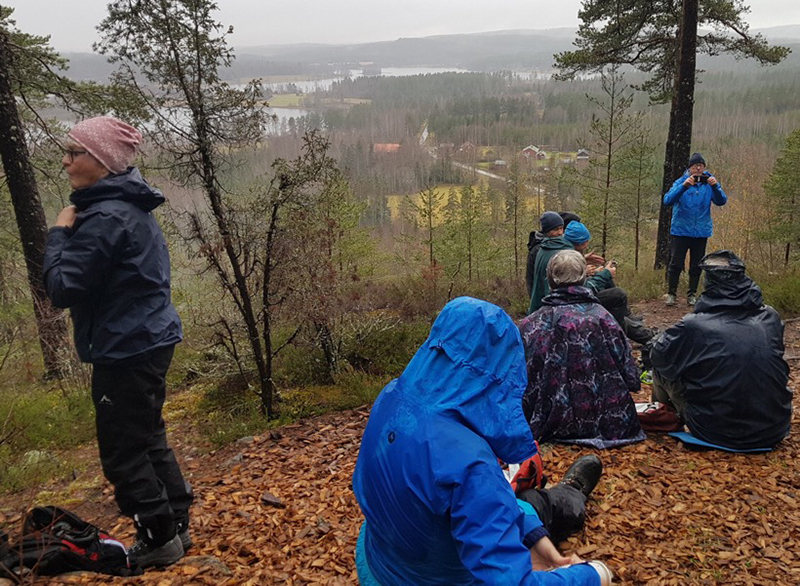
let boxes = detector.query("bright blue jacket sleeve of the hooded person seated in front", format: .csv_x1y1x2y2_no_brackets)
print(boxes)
450,462,600,586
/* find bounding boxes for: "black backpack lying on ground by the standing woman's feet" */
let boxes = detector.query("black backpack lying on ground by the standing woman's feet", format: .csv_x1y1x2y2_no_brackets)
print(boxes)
0,507,142,579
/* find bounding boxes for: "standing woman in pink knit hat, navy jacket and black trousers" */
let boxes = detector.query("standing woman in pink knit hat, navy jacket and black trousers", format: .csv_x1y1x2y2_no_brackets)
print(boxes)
44,116,192,567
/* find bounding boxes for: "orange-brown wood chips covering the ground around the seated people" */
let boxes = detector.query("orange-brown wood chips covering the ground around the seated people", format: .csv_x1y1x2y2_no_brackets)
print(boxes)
0,302,800,586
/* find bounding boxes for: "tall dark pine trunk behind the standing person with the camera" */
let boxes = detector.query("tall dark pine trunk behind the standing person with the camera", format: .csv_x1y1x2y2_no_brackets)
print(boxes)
654,0,698,269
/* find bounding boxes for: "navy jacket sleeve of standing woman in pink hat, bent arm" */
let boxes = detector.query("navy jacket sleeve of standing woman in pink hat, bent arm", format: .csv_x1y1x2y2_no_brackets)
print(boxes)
42,213,125,308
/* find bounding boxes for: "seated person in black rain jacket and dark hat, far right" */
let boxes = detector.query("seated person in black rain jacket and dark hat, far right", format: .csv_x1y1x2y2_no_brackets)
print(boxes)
651,250,792,450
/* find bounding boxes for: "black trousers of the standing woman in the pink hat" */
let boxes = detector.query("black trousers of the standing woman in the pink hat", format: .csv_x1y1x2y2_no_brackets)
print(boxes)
92,346,193,546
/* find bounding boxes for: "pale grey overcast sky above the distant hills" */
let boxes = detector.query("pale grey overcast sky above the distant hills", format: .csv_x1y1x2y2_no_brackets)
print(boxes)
6,0,800,52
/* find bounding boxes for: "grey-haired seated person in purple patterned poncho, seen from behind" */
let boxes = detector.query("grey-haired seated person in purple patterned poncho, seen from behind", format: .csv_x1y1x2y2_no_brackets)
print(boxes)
520,250,645,449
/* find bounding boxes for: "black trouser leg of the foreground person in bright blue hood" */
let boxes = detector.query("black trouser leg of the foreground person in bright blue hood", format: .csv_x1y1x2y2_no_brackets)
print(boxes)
517,484,586,543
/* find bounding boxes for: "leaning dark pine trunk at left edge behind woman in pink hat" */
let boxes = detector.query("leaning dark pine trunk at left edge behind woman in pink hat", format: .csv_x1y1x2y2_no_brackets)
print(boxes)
0,31,72,378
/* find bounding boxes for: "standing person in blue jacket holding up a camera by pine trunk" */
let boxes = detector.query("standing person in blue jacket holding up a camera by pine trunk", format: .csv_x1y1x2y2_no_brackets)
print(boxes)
664,153,728,305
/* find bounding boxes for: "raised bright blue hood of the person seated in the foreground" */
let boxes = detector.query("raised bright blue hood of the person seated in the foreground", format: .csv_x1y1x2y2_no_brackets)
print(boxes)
396,297,535,463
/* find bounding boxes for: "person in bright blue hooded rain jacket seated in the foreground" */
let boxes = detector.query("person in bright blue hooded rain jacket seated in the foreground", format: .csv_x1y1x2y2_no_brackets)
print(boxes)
353,297,611,586
